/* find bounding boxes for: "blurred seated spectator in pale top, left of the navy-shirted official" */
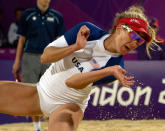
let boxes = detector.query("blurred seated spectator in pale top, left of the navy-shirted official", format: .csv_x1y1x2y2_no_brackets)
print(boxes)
8,8,24,48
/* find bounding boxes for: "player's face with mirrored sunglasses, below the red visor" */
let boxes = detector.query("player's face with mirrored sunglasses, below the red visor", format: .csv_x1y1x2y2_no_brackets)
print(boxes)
116,27,145,55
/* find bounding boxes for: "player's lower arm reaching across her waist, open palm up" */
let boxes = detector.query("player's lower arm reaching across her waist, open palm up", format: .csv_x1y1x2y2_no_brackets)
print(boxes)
65,65,134,89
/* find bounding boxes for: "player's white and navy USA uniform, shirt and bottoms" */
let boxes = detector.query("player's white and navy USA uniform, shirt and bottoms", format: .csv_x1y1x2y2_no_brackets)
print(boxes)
37,22,124,115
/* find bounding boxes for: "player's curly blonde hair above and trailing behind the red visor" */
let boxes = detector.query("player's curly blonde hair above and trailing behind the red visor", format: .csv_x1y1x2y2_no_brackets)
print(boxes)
110,6,158,58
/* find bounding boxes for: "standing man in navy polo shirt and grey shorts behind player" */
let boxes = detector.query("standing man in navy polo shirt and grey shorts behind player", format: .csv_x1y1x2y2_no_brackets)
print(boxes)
13,0,65,131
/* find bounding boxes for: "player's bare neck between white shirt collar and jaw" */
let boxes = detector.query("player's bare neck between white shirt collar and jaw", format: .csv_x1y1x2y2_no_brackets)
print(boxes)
104,34,117,53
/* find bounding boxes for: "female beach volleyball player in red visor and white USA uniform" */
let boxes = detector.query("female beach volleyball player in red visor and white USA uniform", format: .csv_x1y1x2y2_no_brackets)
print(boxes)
0,6,155,131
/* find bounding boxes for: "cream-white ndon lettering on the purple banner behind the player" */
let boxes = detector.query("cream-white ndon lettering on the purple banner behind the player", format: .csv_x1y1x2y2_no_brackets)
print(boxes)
91,79,165,107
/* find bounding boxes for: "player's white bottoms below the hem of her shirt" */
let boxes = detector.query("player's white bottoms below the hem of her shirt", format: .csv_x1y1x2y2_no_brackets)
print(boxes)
37,84,91,116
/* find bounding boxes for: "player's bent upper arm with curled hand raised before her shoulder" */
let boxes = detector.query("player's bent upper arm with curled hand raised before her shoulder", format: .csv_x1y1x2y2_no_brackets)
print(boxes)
41,25,90,64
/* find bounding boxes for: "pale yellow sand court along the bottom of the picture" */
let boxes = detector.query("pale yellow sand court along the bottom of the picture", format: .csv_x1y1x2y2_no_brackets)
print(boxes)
0,120,165,131
